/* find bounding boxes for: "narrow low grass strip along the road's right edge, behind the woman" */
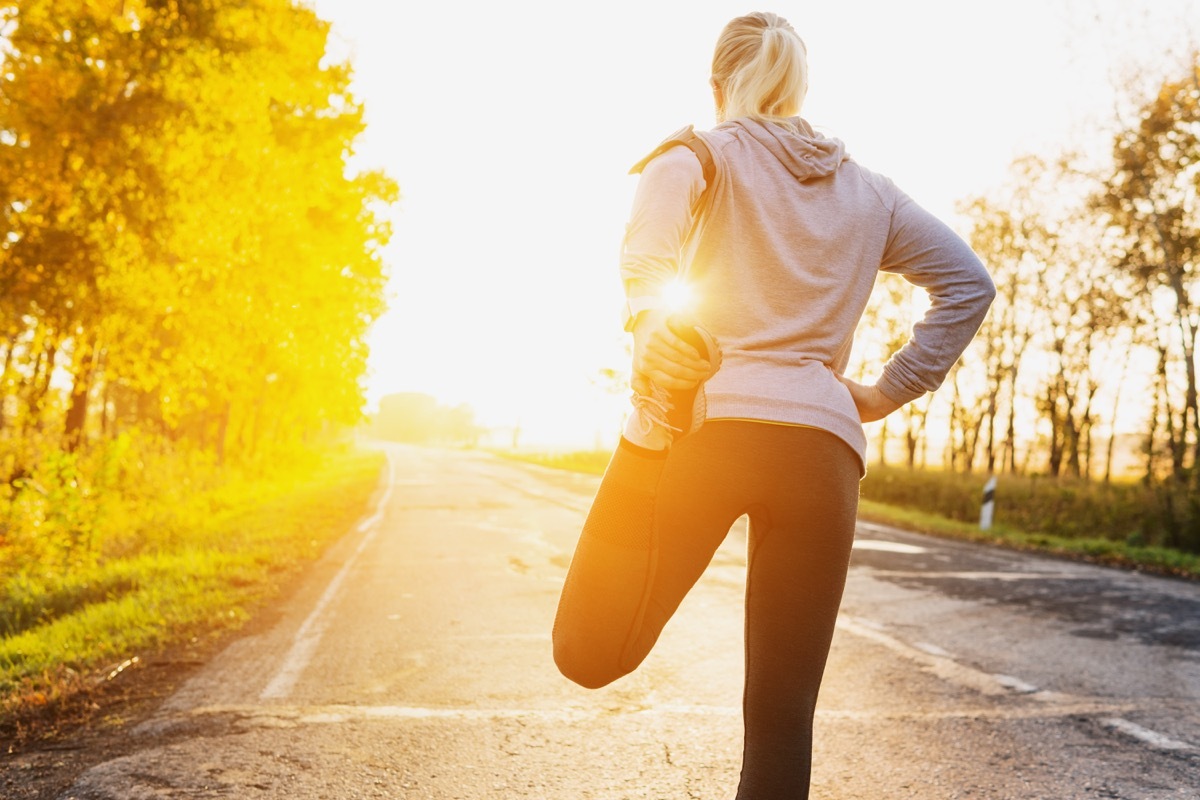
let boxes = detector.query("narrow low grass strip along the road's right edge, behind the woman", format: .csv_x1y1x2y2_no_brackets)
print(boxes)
493,450,1200,579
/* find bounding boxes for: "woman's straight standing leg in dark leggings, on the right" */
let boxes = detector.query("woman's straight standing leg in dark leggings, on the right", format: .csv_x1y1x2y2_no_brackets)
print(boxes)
724,428,859,800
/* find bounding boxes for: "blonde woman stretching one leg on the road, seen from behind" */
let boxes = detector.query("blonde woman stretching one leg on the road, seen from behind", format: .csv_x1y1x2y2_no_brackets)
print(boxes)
554,13,995,800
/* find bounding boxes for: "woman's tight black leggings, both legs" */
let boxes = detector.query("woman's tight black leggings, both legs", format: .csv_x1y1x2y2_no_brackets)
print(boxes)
554,420,859,800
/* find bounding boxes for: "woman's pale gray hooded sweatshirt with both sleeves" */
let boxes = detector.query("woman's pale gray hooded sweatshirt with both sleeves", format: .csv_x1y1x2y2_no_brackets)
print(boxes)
620,118,996,471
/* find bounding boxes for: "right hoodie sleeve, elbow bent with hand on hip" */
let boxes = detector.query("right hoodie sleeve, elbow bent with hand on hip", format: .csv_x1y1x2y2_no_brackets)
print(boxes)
878,186,996,403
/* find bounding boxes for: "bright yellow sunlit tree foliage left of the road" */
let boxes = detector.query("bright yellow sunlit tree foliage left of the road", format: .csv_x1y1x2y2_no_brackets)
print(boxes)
0,0,397,462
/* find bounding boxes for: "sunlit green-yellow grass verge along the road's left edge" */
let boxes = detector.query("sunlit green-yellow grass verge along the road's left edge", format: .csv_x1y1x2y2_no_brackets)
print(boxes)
0,445,384,722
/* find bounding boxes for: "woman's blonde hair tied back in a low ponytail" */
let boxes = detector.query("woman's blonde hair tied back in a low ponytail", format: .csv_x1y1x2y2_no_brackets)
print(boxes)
713,11,809,122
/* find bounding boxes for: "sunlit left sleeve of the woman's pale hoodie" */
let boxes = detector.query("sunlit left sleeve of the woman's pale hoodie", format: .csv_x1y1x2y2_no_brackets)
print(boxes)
620,146,704,330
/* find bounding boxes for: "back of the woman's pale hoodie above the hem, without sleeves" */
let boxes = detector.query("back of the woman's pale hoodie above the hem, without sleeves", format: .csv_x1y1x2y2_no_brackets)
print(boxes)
685,120,889,371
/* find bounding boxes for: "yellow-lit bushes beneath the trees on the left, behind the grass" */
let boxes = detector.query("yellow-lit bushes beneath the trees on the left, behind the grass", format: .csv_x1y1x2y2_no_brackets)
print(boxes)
0,434,369,637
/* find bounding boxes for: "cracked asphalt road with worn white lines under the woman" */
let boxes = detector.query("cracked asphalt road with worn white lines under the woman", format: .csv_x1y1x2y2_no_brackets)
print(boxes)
62,446,1200,800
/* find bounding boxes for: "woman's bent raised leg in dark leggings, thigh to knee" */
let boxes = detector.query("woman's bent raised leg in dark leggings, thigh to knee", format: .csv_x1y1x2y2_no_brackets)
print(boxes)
553,426,744,688
